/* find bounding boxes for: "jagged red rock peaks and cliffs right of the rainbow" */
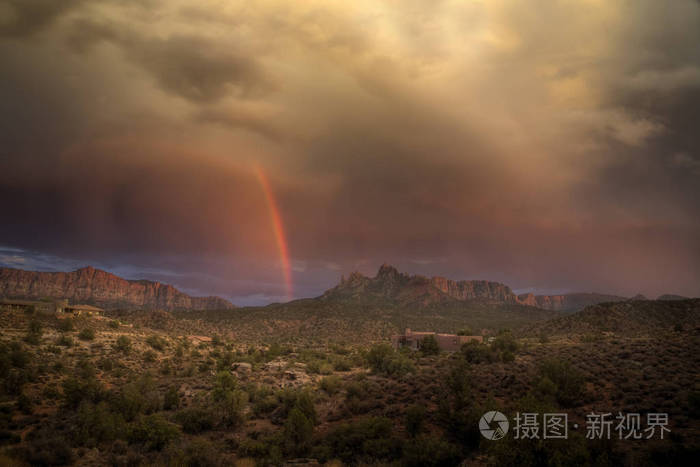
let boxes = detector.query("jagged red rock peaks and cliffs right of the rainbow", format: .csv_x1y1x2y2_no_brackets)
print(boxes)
322,264,626,311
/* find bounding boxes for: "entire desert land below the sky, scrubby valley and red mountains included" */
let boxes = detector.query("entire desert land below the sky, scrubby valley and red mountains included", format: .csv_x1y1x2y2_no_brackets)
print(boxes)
0,265,700,466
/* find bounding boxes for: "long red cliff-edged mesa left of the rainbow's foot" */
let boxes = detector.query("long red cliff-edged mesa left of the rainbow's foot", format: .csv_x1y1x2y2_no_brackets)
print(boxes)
0,266,233,310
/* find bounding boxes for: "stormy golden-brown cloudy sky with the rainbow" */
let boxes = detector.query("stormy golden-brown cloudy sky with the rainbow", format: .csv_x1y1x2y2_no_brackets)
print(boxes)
0,0,700,305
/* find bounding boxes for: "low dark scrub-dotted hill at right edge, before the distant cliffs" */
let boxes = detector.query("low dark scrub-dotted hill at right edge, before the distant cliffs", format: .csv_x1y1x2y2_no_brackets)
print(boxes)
521,298,700,336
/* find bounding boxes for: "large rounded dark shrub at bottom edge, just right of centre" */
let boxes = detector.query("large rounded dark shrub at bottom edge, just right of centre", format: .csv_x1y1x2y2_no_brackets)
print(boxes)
319,417,402,464
